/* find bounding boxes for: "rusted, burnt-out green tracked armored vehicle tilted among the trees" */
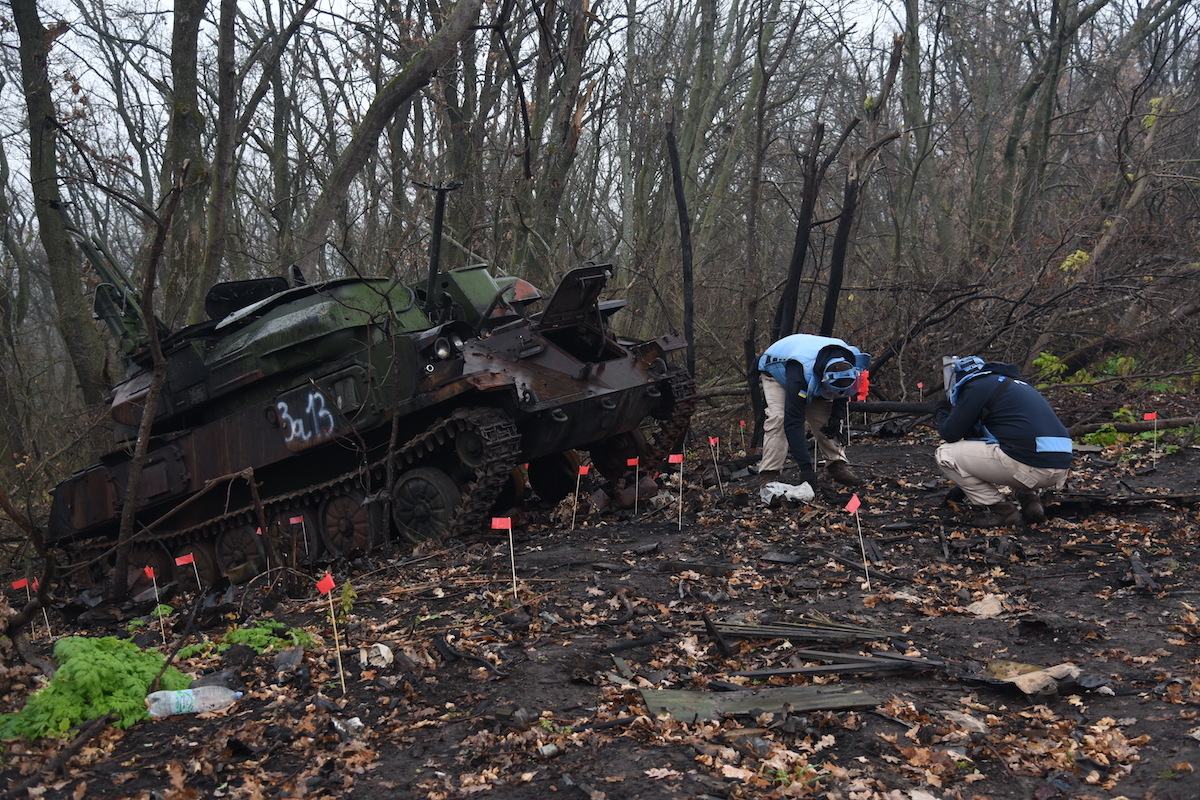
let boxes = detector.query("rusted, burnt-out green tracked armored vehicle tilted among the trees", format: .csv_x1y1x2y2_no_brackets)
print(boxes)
48,206,696,584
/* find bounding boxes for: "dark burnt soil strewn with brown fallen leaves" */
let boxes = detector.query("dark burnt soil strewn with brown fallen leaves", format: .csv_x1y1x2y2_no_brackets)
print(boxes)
0,388,1200,800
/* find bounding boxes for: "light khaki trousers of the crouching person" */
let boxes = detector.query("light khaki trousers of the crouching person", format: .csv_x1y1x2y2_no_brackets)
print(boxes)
935,439,1070,506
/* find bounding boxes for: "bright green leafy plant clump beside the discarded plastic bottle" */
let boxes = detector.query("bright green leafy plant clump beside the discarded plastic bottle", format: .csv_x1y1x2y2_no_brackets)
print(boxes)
0,636,191,739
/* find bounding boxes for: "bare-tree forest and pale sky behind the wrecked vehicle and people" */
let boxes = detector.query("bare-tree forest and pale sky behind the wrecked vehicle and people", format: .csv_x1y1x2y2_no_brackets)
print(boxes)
0,0,1200,525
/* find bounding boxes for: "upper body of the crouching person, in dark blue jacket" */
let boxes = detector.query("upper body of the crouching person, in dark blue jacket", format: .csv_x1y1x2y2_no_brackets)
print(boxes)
937,361,1073,469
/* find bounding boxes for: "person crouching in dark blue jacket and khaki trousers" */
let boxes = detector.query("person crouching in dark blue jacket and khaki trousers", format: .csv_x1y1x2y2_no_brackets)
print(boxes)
936,356,1072,528
